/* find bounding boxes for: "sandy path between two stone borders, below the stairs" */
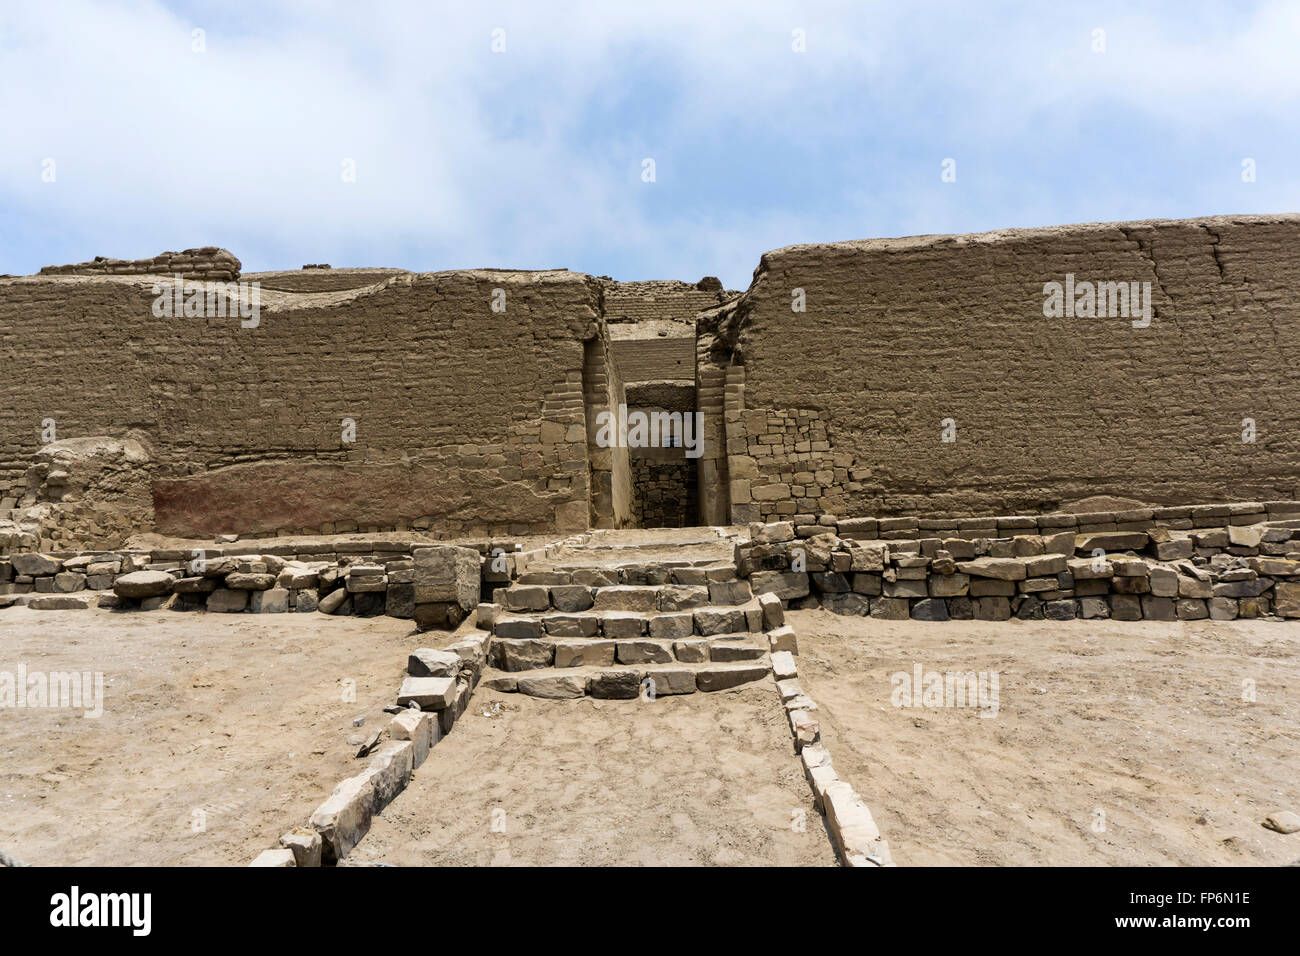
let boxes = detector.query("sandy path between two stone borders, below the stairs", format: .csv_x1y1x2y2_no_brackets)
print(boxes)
346,678,836,866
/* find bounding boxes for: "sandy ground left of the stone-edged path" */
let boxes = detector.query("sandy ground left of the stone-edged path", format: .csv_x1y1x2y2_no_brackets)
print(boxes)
0,607,425,865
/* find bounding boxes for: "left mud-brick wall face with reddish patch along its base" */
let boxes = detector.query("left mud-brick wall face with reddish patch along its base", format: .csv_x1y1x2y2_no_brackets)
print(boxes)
0,271,599,535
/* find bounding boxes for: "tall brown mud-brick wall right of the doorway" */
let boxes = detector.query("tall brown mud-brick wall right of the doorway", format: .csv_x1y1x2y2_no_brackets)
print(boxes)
701,215,1300,520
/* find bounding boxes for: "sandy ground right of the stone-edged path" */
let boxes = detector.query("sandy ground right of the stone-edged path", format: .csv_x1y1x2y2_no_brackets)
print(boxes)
789,611,1300,866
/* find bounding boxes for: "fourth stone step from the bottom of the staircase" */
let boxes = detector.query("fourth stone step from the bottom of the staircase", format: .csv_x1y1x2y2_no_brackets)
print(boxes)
493,580,754,613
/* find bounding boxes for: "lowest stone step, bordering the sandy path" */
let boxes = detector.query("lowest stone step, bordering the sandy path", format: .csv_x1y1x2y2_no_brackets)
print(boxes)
478,659,772,700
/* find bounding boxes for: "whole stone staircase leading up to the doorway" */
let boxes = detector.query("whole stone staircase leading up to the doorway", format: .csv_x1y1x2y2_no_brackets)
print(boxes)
478,529,793,698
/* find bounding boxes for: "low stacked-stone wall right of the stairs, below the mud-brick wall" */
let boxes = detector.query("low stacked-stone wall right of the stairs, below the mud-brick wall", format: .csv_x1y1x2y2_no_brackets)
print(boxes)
736,520,1300,620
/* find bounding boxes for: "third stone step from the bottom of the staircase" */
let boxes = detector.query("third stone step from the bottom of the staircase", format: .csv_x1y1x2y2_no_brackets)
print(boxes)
491,600,763,640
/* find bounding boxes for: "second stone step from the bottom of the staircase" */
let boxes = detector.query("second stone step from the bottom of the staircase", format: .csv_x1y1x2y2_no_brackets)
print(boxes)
489,633,770,672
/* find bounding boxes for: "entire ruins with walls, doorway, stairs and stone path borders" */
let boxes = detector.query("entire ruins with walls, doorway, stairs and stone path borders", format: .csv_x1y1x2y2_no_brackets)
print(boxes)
0,215,1300,865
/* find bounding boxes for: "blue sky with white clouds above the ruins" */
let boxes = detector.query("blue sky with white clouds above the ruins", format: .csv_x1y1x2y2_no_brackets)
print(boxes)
0,0,1300,289
